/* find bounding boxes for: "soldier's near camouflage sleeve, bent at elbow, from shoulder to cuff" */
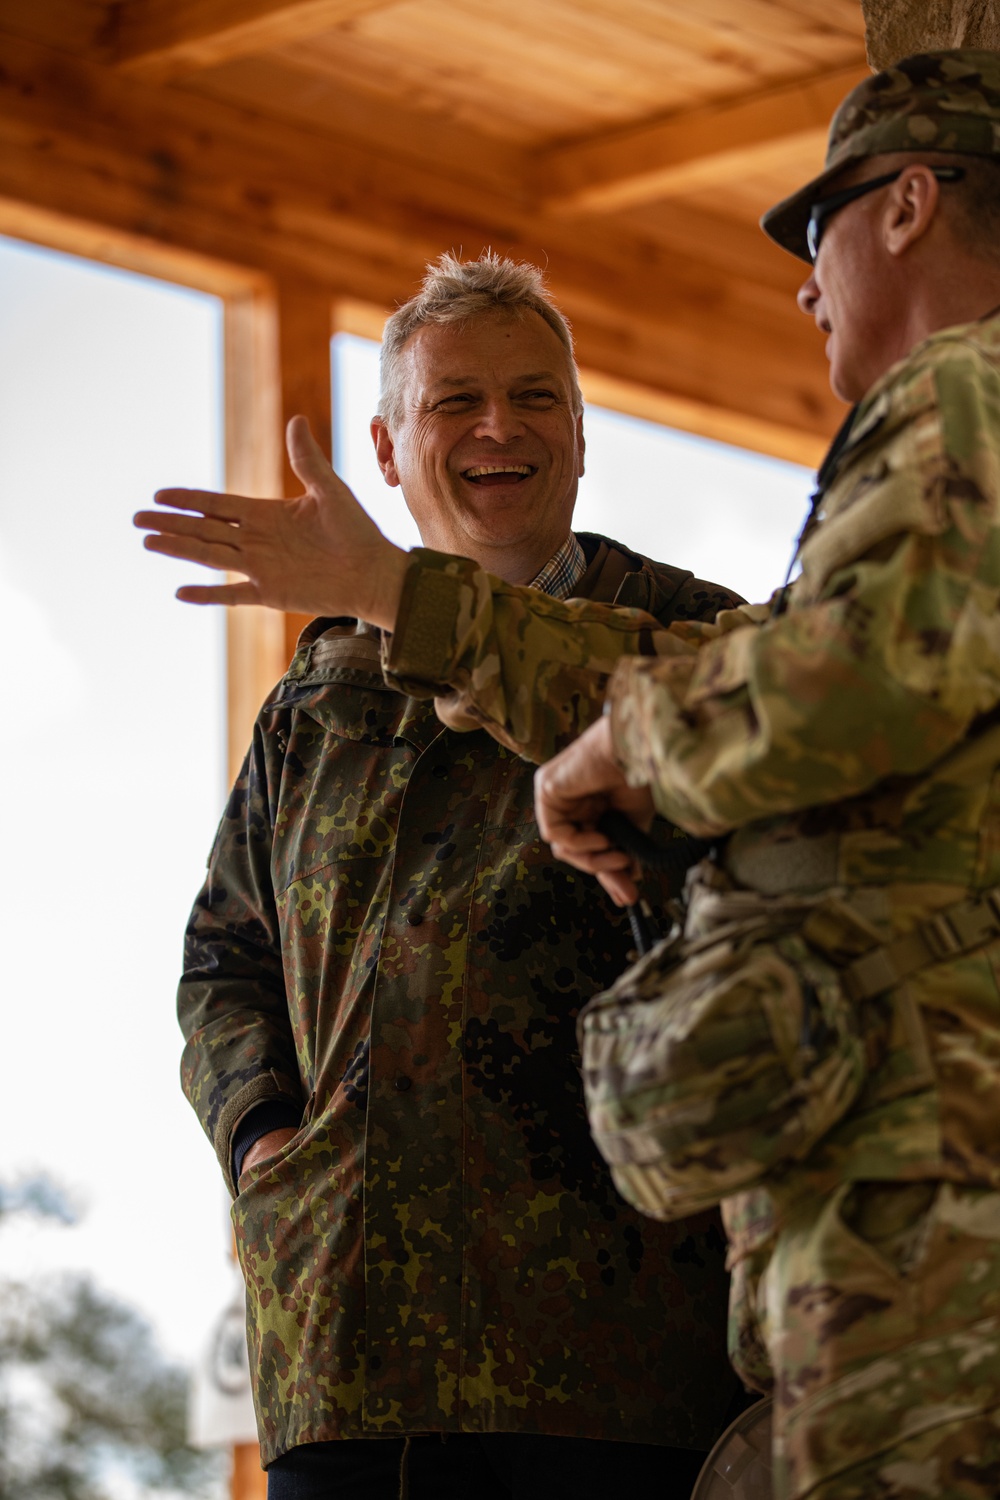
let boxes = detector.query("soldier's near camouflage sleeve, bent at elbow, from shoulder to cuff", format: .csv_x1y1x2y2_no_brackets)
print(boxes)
609,344,1000,834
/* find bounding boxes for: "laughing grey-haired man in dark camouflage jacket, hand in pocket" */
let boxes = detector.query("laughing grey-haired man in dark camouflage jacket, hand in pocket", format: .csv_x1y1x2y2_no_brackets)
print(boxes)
162,257,736,1500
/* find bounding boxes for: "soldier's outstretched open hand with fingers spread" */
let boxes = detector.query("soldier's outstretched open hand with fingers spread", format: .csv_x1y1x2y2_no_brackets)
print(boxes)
133,417,408,630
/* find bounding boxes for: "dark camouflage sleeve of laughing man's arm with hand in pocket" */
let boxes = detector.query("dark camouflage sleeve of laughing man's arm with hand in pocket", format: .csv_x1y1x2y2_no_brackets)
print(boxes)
177,723,301,1194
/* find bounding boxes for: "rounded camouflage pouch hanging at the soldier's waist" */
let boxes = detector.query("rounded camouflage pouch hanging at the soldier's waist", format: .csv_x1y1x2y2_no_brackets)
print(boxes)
579,903,865,1220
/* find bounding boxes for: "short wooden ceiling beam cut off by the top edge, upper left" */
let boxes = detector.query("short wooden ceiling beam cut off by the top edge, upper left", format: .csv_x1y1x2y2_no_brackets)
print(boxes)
114,0,391,83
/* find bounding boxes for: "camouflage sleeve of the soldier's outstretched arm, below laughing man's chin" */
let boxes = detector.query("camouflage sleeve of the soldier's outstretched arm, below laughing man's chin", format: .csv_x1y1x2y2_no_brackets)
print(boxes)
382,548,758,762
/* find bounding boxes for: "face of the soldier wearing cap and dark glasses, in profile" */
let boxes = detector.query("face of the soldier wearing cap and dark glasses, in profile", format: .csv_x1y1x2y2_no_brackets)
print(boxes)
798,165,903,404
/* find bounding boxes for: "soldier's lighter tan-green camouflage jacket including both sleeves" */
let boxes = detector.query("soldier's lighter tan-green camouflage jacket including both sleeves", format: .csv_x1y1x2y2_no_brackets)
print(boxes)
393,315,1000,1206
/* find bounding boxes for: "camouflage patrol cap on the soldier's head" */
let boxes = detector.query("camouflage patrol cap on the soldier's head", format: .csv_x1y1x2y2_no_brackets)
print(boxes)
760,48,1000,263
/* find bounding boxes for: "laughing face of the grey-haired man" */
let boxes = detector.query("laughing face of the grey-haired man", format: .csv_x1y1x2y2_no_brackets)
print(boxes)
372,312,583,578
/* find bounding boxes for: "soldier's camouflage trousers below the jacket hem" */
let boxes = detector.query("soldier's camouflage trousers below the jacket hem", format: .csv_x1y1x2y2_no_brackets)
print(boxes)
759,1182,1000,1500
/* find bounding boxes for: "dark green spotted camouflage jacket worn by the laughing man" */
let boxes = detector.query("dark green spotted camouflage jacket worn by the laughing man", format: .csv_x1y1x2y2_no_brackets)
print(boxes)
180,537,735,1463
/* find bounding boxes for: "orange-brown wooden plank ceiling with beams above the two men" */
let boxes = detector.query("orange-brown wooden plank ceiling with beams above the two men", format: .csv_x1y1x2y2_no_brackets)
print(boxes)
0,0,867,461
